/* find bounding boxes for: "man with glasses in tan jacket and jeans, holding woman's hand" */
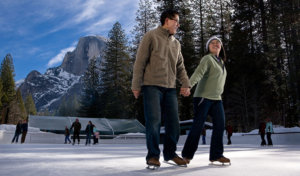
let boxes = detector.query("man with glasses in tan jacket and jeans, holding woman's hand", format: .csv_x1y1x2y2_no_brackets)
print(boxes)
131,10,190,167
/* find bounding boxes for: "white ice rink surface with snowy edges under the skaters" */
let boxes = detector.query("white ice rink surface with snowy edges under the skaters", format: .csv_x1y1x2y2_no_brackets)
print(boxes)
0,125,300,176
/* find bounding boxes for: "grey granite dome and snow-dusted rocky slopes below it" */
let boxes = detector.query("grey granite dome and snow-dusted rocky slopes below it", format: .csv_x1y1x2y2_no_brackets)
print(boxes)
19,36,106,112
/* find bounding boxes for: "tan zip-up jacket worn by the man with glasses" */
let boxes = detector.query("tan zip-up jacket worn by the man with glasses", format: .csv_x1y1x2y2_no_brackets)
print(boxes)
131,26,190,90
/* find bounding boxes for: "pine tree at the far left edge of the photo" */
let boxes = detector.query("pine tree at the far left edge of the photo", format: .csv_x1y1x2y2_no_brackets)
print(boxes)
0,54,16,123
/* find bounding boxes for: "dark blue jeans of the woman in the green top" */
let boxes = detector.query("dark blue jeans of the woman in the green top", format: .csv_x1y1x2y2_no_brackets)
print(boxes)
182,97,225,160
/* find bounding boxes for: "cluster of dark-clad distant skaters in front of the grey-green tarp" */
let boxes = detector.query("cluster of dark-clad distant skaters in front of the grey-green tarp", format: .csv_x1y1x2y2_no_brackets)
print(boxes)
65,118,99,145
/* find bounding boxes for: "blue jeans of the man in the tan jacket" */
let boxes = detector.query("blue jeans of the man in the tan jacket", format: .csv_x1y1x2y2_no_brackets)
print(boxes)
142,86,180,161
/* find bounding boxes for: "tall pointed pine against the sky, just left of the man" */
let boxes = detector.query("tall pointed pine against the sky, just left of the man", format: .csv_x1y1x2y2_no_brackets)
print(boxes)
100,22,132,118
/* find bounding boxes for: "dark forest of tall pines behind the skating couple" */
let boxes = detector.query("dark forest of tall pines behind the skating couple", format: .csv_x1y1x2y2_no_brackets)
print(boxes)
0,0,300,131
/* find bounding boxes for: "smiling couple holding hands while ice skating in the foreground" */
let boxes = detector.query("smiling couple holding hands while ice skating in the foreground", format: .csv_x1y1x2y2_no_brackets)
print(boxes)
131,10,230,167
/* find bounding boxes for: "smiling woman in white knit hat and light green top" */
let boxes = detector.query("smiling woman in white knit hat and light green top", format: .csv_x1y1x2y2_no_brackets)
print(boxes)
182,36,230,164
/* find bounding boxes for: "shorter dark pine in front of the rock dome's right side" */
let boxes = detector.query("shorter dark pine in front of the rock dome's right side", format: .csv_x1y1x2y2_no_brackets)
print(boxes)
78,57,101,117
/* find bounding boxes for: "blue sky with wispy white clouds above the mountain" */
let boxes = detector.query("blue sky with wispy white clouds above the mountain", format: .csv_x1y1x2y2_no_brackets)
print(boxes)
0,0,139,81
